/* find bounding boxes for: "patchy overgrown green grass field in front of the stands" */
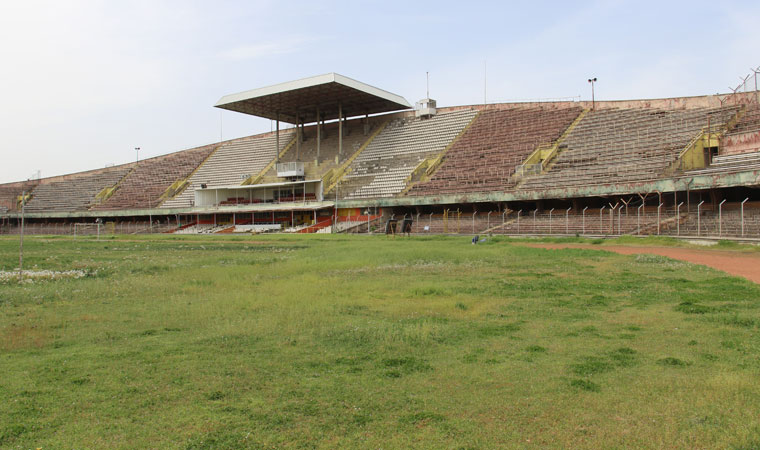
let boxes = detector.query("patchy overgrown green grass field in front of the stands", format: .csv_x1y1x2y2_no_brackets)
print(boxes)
0,236,760,449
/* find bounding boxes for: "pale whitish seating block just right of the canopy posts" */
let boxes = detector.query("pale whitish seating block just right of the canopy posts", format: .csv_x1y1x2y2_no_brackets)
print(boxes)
338,110,476,198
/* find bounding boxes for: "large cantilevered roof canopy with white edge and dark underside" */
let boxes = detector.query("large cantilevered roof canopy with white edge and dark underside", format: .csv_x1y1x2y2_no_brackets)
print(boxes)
214,73,412,124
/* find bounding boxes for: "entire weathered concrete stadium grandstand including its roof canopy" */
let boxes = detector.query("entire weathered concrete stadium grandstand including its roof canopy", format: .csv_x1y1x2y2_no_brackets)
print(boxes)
0,73,760,238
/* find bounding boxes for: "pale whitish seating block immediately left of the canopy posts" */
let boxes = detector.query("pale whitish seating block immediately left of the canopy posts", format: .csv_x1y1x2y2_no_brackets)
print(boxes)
161,129,295,208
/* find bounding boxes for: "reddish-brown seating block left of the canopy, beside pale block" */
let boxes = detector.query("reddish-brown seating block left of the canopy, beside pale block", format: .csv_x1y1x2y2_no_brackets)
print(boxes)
92,145,216,210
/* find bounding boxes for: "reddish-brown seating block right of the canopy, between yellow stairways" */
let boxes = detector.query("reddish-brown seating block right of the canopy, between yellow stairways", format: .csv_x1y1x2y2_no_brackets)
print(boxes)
409,108,582,195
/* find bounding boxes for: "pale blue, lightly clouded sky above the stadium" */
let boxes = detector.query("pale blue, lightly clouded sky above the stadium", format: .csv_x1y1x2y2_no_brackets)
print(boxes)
0,0,760,182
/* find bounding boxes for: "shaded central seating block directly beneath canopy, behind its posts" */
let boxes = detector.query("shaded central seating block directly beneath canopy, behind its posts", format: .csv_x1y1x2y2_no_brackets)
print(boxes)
259,118,382,188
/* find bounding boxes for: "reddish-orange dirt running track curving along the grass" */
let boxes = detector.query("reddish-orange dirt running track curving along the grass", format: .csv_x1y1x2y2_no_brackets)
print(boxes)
524,243,760,283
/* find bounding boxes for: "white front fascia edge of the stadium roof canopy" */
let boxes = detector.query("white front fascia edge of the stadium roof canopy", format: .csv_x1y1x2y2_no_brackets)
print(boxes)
214,72,412,108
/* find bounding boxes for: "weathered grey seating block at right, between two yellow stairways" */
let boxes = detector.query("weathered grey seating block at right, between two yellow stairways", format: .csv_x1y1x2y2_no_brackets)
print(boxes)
519,107,737,190
